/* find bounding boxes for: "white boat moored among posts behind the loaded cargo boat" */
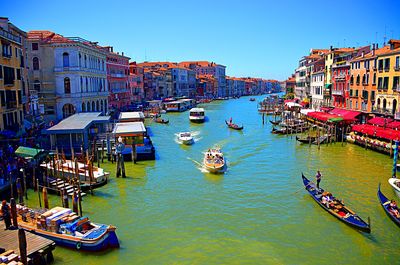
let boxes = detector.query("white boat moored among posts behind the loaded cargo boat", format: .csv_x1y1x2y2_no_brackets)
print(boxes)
40,159,110,191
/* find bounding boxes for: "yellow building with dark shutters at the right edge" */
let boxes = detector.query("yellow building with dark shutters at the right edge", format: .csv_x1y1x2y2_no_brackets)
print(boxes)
373,40,400,118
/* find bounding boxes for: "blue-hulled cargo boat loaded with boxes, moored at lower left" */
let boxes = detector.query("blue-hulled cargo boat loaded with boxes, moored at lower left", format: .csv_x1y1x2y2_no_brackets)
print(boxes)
17,205,119,251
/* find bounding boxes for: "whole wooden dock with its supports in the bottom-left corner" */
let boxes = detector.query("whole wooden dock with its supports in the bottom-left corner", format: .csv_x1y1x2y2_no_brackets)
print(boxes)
0,220,56,264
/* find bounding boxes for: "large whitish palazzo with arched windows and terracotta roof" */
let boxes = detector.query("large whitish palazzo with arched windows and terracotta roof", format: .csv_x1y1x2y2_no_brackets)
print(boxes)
28,30,109,122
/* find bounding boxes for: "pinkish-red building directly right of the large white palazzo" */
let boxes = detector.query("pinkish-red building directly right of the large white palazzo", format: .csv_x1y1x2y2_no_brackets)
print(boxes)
102,46,132,110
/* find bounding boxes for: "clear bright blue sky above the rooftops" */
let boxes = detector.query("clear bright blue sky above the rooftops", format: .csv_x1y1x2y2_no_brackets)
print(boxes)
0,0,400,80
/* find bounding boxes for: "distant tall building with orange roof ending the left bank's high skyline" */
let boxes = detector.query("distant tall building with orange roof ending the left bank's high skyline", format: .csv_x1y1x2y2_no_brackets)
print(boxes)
178,61,226,97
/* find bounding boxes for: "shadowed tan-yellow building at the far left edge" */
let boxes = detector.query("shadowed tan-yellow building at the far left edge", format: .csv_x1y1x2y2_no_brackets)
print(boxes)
0,17,27,131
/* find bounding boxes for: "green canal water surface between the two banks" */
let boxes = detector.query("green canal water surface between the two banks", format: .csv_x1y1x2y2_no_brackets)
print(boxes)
28,97,400,265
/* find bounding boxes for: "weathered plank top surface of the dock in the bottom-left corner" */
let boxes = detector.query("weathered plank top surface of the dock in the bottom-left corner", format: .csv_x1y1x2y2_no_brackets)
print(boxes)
0,221,55,258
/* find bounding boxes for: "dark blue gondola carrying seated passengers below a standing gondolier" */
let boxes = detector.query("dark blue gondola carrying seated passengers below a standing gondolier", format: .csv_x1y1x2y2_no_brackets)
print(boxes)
301,174,371,233
